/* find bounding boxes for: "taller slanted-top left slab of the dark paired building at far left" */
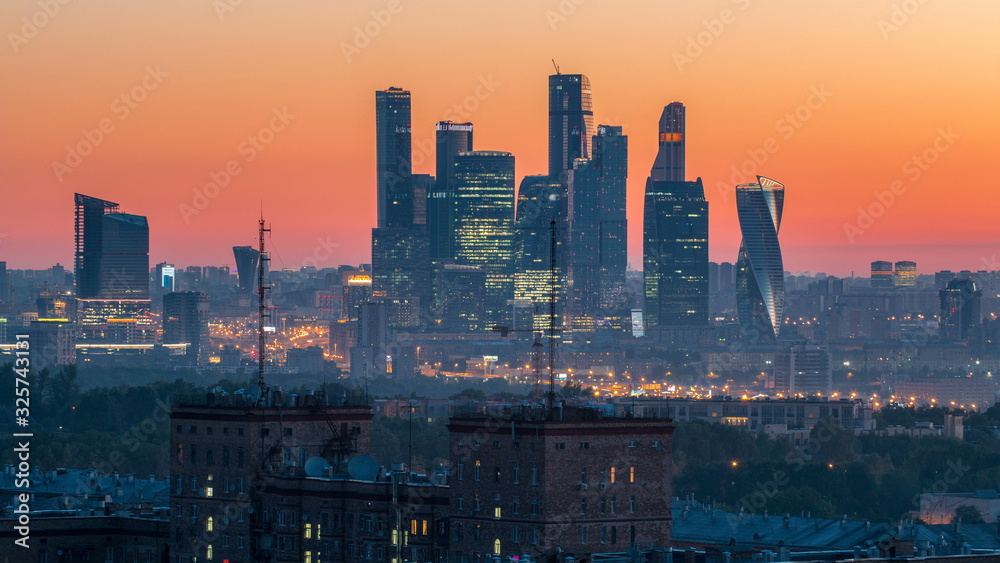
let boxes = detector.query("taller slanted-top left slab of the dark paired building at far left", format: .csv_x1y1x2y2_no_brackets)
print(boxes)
73,194,118,299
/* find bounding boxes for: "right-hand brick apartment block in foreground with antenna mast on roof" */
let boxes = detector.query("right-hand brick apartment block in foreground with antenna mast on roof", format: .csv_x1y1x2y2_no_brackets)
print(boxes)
448,406,673,563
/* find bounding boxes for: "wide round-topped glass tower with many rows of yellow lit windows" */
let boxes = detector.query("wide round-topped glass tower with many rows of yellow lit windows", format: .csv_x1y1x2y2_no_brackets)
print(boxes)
455,151,514,326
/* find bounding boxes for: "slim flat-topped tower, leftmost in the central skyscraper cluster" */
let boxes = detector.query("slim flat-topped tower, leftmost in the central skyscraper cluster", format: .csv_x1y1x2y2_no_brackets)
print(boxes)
375,88,413,228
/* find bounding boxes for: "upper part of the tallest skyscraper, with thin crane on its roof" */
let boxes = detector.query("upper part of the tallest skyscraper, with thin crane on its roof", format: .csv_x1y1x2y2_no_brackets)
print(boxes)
549,74,594,178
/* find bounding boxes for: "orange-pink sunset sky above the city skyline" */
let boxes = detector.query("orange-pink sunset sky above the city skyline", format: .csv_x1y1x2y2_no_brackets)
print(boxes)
0,0,1000,274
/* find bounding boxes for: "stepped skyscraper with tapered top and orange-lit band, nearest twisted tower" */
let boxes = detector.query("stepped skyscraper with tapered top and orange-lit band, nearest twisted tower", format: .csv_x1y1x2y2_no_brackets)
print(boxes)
642,102,709,328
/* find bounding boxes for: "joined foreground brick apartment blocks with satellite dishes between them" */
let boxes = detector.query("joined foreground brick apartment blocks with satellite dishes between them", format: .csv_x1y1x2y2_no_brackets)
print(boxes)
164,393,673,563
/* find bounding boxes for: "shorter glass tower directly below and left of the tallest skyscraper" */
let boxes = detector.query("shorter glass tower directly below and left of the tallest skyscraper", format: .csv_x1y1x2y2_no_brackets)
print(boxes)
514,176,567,331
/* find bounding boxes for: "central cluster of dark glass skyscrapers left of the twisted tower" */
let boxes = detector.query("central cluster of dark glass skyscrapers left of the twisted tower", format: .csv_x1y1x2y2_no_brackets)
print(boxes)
372,72,728,344
